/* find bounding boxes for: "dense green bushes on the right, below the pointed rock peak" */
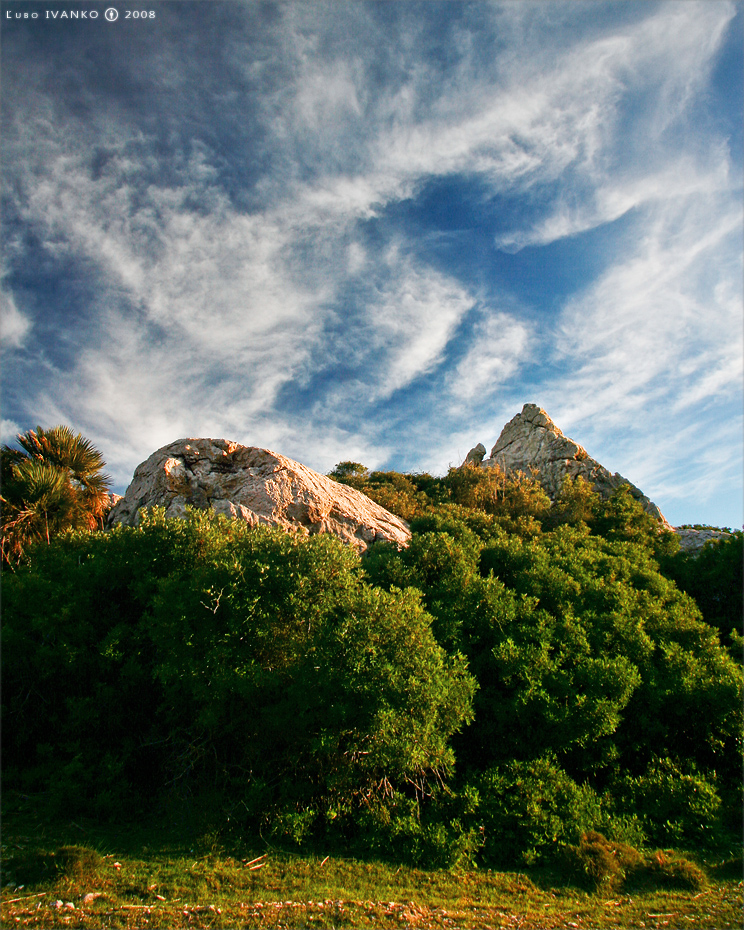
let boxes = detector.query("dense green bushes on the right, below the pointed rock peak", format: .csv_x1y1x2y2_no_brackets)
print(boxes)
365,496,742,859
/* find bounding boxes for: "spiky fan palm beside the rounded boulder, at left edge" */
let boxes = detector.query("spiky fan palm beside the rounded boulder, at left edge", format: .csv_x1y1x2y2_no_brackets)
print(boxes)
0,426,111,565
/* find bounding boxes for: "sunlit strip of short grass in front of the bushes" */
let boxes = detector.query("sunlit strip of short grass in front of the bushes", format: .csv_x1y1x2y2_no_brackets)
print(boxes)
1,792,742,930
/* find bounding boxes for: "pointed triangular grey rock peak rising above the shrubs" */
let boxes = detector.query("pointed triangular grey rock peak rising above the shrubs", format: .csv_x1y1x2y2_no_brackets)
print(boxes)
465,404,671,529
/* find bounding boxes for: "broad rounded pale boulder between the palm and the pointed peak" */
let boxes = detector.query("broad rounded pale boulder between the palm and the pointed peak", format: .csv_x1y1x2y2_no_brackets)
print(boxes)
108,439,411,552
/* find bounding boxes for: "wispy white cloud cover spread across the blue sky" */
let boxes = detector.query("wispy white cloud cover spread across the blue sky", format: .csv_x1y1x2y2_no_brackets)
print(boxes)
3,3,741,516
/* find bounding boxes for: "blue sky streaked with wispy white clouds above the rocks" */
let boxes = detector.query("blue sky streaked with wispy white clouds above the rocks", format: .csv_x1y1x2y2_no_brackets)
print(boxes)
0,0,744,527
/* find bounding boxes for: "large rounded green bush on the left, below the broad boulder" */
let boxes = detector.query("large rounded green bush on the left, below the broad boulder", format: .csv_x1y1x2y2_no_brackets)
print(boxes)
3,512,474,840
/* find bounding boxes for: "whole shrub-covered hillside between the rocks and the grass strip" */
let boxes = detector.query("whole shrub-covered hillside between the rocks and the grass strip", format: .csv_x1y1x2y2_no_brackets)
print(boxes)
2,462,742,866
